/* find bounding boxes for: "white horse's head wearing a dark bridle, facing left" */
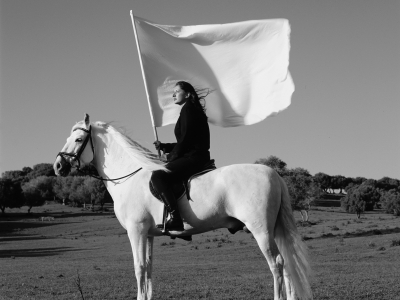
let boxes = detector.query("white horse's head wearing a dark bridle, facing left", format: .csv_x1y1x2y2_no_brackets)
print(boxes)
53,114,94,176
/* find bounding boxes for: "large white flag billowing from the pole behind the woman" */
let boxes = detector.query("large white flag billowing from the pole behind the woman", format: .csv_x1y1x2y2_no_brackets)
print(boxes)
131,13,294,127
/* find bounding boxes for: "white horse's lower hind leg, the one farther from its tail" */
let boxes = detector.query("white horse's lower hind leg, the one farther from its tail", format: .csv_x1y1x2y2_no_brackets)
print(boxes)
252,232,284,300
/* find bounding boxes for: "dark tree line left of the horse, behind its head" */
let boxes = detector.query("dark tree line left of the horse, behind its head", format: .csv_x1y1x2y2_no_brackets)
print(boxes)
0,163,112,213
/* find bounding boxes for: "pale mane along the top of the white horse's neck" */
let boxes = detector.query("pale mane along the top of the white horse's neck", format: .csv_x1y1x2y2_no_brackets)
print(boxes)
73,122,167,171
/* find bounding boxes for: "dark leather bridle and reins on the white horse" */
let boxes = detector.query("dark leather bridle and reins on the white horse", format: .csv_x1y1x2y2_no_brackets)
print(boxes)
56,125,142,181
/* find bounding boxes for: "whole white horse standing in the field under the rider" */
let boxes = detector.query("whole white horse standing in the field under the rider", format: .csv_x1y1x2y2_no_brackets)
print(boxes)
54,114,312,300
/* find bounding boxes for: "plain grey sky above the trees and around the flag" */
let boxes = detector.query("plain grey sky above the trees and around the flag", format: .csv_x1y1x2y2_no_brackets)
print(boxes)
0,0,400,179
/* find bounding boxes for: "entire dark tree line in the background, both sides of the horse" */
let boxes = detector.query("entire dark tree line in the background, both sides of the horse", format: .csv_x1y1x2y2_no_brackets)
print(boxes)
0,155,400,220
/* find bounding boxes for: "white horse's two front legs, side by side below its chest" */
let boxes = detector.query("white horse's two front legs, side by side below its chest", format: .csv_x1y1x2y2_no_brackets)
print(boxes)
128,225,152,300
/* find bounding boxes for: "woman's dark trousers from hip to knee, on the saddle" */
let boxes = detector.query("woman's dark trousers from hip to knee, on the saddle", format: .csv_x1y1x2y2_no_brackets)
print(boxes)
151,156,210,194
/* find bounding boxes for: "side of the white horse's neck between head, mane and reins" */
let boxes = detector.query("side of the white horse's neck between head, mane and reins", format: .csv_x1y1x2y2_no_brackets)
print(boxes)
94,131,140,179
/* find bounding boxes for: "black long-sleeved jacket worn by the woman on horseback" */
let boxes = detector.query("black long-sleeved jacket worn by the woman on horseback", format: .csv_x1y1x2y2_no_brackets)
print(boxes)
161,100,210,161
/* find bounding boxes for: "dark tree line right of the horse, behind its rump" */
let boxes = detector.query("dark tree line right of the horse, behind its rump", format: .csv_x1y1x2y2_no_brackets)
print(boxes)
255,155,400,220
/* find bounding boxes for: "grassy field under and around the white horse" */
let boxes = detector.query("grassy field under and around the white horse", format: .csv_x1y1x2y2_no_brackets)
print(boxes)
0,204,400,300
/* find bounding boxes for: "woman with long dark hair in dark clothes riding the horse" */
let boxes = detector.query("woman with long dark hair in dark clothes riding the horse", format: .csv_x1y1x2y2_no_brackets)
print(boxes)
151,81,210,231
